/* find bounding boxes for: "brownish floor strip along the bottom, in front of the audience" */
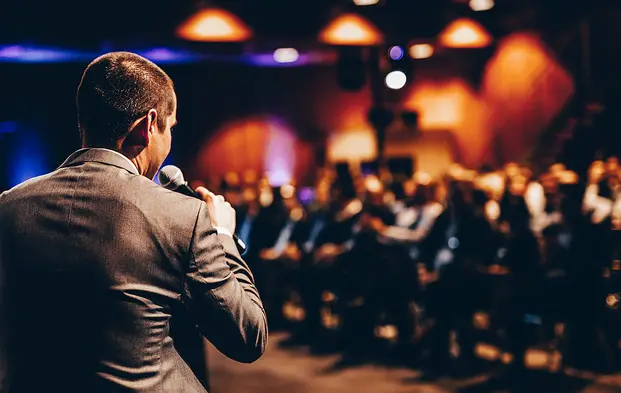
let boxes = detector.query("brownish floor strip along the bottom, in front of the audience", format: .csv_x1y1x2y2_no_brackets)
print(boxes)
209,334,621,393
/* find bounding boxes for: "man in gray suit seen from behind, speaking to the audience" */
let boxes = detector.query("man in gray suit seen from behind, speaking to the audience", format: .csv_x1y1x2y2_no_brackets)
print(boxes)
0,52,267,393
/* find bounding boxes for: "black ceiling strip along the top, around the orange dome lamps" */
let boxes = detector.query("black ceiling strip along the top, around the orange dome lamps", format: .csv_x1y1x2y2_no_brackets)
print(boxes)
0,0,595,48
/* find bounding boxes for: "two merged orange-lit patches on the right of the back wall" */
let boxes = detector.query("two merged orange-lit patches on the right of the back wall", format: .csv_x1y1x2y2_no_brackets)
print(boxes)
405,33,573,166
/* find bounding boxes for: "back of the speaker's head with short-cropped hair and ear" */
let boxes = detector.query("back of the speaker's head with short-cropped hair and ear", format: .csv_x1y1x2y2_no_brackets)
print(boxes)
76,52,175,147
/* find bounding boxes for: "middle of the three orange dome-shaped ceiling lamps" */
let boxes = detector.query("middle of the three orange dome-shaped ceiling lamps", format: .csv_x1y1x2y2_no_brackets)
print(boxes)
319,14,384,46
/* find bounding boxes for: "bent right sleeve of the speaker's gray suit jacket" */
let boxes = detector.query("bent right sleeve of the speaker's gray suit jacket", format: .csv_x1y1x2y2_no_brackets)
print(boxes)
184,203,268,363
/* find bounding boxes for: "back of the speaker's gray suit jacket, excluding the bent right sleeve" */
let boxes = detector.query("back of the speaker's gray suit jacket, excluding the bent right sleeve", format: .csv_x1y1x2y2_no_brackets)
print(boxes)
0,151,211,392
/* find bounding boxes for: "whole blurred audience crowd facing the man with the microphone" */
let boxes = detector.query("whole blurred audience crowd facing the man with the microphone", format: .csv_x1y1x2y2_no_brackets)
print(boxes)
206,157,621,378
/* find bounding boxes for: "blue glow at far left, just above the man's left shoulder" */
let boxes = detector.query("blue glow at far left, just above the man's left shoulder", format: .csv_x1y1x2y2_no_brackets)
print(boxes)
9,126,49,187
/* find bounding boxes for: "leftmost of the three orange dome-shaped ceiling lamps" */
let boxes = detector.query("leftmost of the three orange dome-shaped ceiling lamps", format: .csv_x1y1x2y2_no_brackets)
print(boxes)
177,8,252,42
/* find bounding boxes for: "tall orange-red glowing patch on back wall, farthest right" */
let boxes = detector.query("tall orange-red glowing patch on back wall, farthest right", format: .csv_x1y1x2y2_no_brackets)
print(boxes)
481,34,574,164
